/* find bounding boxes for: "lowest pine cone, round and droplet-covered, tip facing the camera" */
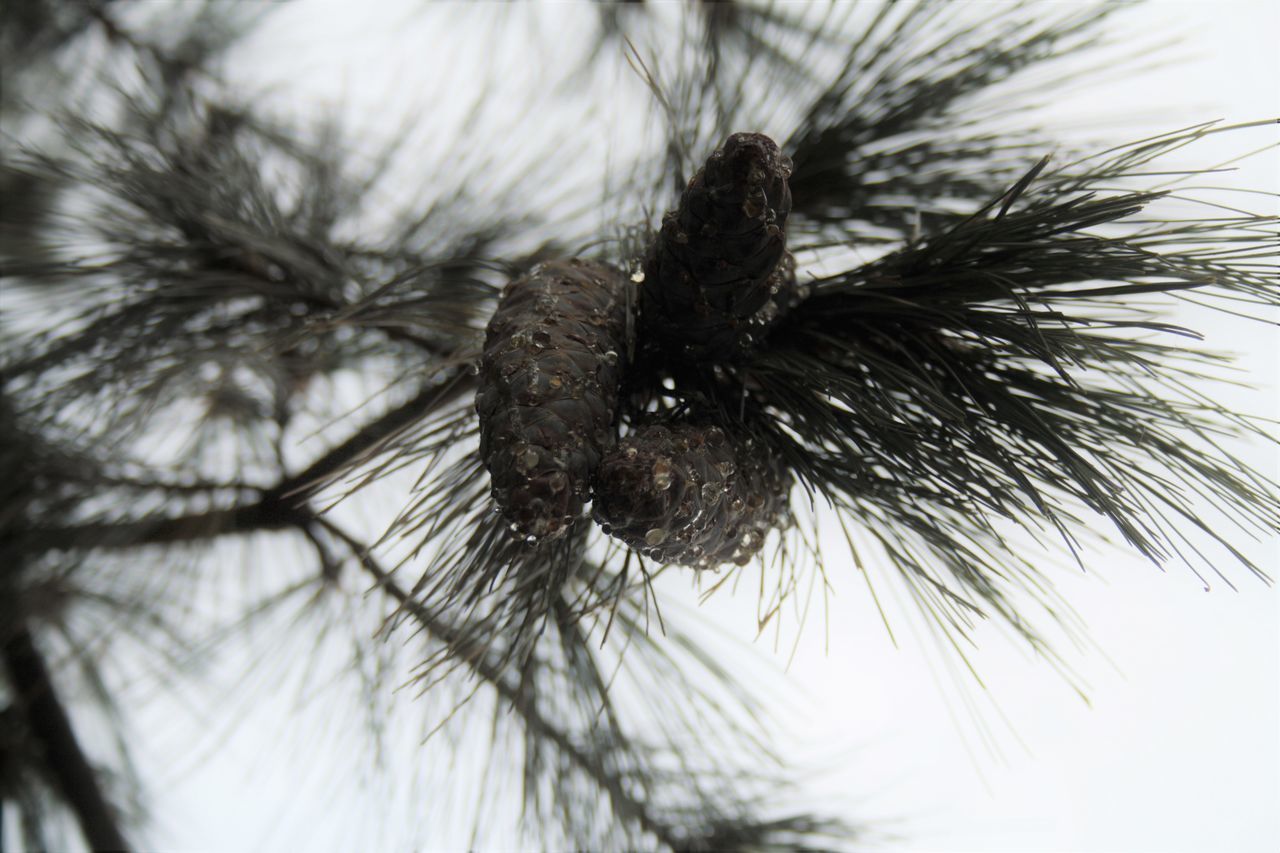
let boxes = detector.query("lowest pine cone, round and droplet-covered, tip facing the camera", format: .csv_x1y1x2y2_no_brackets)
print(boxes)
594,423,791,569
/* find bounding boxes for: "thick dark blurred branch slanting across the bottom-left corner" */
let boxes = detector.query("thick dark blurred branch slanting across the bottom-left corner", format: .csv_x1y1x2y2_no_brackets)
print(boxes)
3,626,129,850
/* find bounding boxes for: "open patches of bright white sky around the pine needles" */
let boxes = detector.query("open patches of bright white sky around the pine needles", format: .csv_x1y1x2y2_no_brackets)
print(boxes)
94,1,1280,852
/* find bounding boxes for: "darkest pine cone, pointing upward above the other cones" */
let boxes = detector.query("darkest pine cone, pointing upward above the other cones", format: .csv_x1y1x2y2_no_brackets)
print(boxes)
641,133,796,361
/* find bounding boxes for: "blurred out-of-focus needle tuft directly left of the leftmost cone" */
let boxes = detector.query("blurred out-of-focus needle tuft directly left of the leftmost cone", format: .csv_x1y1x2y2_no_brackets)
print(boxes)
8,87,503,465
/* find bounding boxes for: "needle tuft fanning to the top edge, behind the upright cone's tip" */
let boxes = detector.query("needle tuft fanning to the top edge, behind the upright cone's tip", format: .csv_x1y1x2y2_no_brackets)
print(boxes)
782,0,1132,242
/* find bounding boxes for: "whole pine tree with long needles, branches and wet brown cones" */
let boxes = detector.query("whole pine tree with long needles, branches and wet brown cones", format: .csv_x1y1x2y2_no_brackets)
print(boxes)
0,0,1280,850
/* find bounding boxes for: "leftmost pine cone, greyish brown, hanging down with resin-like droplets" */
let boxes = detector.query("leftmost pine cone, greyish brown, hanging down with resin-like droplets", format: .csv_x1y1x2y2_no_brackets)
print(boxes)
476,259,630,539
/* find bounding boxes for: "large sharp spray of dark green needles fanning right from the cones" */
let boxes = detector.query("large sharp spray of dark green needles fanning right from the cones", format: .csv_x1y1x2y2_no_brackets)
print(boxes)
742,133,1280,640
